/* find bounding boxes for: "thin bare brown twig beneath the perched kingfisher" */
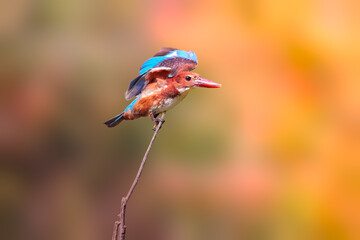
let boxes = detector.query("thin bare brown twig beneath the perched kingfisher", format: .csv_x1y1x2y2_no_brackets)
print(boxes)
112,112,165,240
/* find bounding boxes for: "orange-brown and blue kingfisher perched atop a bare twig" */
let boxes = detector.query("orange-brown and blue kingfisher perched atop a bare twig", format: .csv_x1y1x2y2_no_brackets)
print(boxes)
105,47,221,130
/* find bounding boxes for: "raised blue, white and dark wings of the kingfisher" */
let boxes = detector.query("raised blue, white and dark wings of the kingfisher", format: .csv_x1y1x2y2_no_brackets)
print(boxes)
125,48,198,100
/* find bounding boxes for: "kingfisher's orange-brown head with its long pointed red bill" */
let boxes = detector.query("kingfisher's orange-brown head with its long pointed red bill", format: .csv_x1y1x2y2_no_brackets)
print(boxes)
174,72,221,92
